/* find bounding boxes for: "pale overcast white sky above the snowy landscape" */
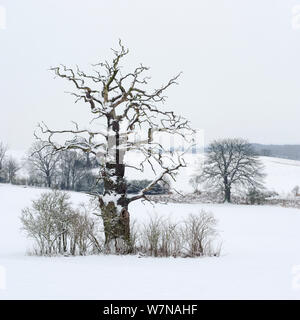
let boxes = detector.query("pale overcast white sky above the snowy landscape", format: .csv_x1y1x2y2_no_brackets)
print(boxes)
0,0,300,149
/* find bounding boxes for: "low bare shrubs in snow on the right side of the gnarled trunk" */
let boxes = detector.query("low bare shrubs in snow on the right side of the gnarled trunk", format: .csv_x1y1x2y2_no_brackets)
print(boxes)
136,211,221,257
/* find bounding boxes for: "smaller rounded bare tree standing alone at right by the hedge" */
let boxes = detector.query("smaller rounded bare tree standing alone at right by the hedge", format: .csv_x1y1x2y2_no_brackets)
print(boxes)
200,139,264,202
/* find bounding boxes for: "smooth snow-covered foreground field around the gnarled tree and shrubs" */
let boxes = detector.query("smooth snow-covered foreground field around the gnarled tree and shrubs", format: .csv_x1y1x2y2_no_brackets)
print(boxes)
0,184,300,299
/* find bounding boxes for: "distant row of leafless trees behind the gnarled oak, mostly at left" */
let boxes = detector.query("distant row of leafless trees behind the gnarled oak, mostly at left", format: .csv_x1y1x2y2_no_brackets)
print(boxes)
0,141,169,194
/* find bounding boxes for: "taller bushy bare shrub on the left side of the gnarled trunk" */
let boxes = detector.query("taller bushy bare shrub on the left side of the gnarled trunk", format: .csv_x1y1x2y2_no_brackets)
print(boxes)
21,190,102,255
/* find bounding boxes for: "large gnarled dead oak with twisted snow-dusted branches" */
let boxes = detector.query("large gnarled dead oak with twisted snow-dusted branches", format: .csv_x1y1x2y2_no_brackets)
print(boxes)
36,42,192,252
